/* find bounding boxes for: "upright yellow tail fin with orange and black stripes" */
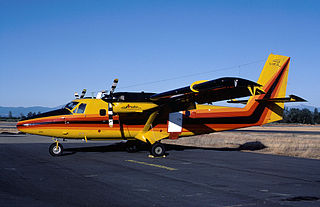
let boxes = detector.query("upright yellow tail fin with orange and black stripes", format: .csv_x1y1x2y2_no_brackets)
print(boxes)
246,54,290,125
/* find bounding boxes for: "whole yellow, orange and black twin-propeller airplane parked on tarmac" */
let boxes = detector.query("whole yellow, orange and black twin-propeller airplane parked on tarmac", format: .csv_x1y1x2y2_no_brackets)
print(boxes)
17,54,306,157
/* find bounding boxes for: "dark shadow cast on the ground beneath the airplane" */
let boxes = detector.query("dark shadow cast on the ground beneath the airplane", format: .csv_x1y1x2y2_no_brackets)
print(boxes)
64,141,266,155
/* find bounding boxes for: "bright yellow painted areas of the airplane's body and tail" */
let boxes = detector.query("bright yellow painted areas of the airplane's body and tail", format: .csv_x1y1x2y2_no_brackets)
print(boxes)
16,54,289,144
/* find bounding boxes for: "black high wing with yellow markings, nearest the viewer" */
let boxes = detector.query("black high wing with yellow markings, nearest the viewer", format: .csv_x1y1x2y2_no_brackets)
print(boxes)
150,77,264,111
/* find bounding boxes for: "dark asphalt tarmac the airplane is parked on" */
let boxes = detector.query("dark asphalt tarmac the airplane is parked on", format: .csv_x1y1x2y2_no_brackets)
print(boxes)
0,135,320,207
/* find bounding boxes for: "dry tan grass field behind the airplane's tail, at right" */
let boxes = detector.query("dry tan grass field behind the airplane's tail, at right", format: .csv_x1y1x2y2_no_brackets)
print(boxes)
163,126,320,159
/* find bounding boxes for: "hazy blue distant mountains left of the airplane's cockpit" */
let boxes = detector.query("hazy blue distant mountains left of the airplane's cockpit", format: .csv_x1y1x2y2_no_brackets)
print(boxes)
0,106,60,117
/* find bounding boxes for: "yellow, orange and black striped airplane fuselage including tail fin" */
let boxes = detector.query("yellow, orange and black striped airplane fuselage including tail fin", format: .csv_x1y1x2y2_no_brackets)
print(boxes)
17,55,290,144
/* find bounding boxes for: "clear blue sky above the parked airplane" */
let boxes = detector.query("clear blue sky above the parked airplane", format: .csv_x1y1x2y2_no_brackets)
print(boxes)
0,0,320,107
